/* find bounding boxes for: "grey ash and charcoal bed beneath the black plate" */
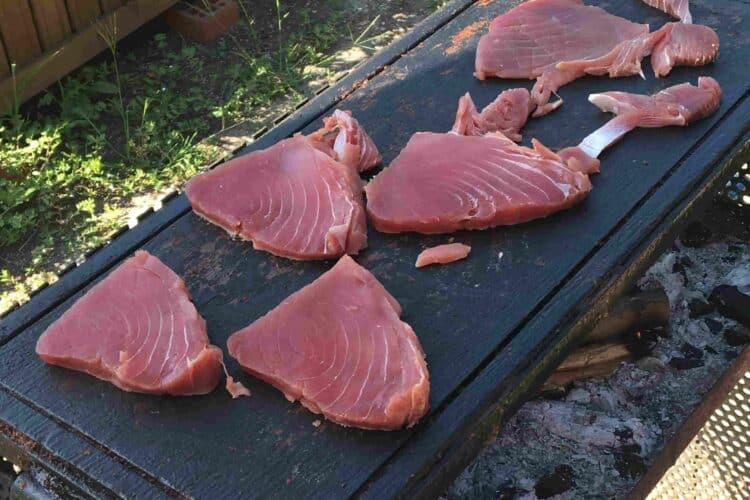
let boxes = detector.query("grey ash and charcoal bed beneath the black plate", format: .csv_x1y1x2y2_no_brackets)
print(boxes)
445,221,750,499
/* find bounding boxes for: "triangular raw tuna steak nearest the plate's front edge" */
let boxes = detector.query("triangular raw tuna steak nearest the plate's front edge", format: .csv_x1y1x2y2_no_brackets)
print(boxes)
228,256,430,429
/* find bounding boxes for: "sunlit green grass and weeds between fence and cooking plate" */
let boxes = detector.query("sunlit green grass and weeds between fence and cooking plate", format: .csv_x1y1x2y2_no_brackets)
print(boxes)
0,1,344,310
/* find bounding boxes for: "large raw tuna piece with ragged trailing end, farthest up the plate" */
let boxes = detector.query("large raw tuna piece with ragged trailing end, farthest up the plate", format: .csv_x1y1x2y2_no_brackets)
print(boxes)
474,0,718,116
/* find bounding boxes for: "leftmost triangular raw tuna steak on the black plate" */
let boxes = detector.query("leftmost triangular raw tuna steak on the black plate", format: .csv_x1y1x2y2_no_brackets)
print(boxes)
36,251,222,396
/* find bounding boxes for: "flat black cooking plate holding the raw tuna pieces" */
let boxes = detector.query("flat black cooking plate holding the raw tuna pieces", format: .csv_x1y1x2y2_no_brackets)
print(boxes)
0,0,750,498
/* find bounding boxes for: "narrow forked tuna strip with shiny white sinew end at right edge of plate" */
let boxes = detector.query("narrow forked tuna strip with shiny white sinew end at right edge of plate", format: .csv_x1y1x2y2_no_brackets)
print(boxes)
578,76,722,157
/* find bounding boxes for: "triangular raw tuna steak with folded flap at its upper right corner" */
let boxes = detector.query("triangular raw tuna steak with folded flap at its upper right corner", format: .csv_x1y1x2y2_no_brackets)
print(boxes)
186,112,380,260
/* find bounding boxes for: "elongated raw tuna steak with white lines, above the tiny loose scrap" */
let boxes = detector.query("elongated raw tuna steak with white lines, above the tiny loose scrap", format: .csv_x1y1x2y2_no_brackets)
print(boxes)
365,132,598,234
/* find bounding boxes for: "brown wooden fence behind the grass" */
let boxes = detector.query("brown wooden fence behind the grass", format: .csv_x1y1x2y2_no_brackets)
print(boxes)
0,0,177,112
